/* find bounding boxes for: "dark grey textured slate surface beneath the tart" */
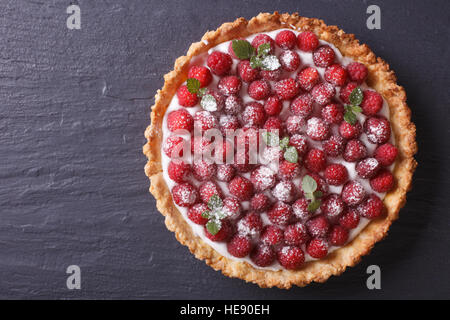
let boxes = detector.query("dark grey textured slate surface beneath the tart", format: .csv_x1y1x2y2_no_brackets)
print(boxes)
0,0,450,299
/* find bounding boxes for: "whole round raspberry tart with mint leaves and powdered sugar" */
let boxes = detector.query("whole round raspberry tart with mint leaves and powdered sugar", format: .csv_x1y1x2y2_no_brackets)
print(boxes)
144,12,417,288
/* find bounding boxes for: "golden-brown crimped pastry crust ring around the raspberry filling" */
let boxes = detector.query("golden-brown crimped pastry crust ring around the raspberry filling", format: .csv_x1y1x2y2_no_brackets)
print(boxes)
143,12,417,289
